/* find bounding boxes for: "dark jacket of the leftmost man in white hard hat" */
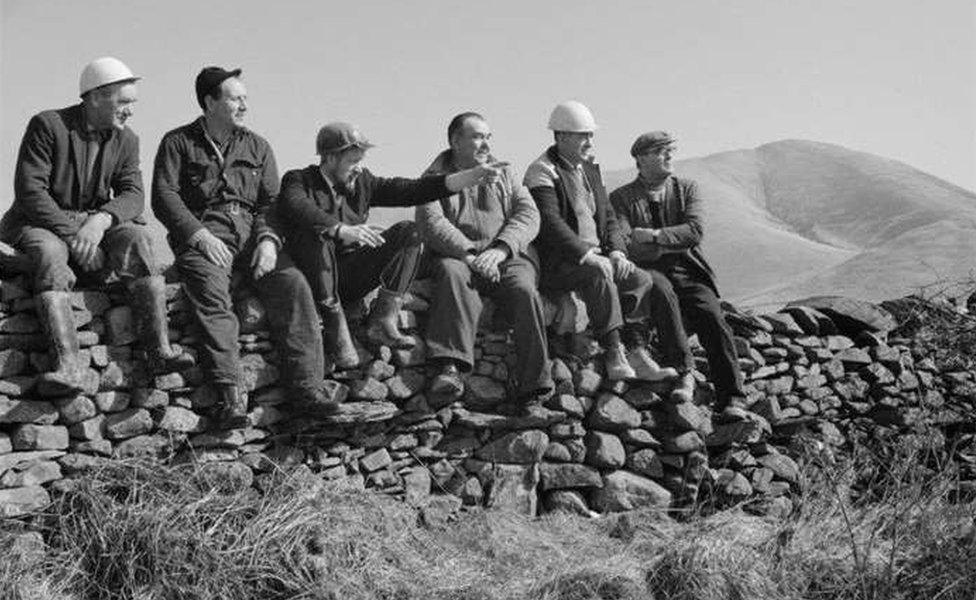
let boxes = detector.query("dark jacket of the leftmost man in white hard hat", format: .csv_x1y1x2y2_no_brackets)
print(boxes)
4,104,145,238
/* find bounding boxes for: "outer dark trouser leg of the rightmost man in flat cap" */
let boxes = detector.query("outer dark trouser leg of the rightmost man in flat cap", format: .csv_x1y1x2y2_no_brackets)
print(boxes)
661,265,745,401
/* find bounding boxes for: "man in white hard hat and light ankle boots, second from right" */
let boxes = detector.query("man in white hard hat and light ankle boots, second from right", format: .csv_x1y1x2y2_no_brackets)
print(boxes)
525,100,694,399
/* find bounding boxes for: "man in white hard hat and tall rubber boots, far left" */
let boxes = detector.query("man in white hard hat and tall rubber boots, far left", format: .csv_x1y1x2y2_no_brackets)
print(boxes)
0,56,193,396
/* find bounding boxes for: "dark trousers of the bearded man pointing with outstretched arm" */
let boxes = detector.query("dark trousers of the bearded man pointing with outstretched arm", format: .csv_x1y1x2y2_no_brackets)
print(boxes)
288,221,423,304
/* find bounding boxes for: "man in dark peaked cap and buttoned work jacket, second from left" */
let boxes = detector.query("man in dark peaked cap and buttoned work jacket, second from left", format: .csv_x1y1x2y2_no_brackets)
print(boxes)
152,67,335,428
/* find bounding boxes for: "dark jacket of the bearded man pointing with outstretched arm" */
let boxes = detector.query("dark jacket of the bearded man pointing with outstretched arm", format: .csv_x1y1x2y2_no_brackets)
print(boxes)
278,165,451,237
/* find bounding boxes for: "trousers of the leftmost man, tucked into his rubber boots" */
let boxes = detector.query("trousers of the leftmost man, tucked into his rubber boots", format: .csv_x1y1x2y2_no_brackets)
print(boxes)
2,212,159,294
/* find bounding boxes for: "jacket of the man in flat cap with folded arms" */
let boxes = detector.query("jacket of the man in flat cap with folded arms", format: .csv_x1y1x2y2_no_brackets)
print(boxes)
610,176,718,295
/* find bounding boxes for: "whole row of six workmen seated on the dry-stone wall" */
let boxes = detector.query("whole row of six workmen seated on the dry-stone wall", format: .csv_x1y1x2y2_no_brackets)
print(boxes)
0,57,742,427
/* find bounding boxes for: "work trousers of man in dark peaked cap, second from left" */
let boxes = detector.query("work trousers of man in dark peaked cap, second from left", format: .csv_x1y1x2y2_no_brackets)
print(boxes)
176,210,325,388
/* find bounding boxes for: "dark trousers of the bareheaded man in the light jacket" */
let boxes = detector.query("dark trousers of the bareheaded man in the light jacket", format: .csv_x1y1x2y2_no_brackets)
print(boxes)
427,256,552,395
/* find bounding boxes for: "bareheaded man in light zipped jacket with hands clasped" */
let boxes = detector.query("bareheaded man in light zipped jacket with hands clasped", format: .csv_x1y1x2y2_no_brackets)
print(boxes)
417,112,552,412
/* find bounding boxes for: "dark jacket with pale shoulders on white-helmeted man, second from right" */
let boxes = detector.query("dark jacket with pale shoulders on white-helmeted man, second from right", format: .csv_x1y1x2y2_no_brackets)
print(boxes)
529,146,627,271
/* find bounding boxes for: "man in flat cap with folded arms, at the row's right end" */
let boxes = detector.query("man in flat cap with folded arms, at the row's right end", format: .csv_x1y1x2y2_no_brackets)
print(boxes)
610,131,744,413
